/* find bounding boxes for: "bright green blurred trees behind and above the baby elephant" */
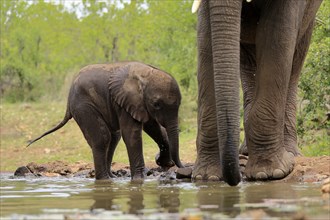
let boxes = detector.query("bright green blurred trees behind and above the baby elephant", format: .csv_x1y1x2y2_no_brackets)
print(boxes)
0,0,196,102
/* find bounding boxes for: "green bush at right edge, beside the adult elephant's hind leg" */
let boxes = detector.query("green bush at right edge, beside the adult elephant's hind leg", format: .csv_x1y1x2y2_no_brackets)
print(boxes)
297,0,330,155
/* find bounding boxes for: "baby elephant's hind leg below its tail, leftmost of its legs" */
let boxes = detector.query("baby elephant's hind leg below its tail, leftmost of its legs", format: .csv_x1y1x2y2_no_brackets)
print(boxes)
73,105,111,180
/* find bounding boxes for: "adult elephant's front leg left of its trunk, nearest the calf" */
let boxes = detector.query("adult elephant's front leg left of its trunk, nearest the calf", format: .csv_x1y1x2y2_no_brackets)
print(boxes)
192,1,222,180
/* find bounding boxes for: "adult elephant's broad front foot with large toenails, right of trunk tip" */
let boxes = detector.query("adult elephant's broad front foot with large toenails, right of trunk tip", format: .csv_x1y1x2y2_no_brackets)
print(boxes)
244,148,294,180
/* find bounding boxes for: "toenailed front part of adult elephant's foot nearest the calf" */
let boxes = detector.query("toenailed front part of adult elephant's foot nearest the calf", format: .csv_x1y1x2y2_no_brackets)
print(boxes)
192,159,222,181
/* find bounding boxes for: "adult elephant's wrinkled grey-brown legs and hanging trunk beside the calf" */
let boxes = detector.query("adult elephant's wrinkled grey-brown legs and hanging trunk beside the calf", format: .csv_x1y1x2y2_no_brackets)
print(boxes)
192,0,321,185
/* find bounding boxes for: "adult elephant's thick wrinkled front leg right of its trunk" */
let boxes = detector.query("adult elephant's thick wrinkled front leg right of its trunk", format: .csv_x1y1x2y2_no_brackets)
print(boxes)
245,0,304,180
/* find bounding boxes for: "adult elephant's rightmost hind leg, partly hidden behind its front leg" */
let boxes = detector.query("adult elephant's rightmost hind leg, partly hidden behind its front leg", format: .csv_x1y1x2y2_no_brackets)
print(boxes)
284,22,314,156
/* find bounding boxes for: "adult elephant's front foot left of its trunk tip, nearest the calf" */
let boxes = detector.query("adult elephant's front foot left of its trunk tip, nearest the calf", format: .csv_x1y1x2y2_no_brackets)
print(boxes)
192,155,222,181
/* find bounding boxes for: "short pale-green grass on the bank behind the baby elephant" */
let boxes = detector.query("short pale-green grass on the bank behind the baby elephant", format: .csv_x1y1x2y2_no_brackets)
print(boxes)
0,92,330,172
